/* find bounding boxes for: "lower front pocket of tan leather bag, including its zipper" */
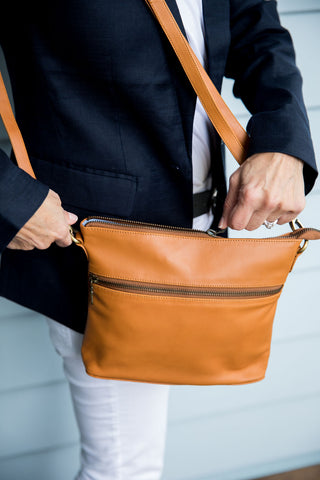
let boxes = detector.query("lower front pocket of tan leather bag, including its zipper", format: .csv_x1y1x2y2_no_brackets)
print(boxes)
82,275,282,385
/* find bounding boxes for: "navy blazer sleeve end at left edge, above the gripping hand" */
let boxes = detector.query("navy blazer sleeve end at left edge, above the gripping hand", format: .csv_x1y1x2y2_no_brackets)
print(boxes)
0,149,49,253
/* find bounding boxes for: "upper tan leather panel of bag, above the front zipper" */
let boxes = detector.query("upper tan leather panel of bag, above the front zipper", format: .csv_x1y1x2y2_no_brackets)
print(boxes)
81,226,301,287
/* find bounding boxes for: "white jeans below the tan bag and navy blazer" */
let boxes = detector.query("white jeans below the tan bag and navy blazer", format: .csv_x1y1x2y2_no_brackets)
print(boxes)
47,319,169,480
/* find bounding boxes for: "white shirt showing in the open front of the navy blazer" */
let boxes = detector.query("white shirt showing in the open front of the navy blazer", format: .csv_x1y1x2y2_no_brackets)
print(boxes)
176,0,213,230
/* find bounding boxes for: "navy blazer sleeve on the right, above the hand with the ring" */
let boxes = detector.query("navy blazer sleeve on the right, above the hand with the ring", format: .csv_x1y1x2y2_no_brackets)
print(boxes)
225,0,317,193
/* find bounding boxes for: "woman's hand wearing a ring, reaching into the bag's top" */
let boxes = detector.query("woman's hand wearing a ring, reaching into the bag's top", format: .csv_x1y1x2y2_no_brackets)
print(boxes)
219,153,305,230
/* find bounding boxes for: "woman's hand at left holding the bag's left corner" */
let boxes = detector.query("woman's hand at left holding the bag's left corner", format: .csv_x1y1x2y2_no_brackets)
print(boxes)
7,190,78,250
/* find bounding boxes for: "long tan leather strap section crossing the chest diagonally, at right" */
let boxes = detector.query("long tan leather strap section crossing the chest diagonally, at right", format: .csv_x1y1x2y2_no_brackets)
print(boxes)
145,0,249,165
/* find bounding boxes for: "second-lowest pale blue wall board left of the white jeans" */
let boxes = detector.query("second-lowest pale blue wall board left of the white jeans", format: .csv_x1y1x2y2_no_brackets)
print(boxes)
0,383,78,458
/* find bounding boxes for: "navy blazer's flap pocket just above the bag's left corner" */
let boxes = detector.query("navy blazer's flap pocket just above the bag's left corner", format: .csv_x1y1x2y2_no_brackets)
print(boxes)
31,157,138,217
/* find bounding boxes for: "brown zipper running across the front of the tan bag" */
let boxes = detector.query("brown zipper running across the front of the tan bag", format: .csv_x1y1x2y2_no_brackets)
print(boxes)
89,273,282,304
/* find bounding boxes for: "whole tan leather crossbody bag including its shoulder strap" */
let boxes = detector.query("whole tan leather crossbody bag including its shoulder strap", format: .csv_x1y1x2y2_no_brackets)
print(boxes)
0,0,320,385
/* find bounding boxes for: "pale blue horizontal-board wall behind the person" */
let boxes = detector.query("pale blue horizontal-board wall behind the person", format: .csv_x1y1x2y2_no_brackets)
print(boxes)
0,0,320,480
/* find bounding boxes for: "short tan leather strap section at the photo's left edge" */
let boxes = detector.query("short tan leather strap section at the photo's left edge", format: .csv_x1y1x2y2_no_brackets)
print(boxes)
0,73,36,178
